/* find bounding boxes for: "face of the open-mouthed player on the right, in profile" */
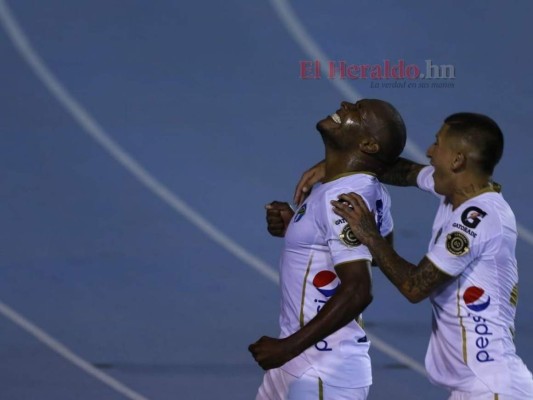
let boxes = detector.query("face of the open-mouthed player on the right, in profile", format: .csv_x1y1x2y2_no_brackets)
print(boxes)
427,124,456,196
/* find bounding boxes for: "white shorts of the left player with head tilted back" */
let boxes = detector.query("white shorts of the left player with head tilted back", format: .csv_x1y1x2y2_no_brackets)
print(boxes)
255,368,370,400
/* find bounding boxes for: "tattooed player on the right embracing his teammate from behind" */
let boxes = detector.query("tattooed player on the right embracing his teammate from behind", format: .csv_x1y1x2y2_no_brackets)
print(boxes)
297,113,533,400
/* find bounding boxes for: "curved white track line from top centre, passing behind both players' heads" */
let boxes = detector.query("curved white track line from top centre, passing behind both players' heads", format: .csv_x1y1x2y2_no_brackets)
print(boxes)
270,0,533,245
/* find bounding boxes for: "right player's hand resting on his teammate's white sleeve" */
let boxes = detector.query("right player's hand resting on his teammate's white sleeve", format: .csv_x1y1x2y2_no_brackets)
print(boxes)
331,193,380,245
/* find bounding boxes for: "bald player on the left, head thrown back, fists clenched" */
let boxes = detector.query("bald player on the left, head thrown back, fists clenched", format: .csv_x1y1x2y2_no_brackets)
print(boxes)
249,99,406,400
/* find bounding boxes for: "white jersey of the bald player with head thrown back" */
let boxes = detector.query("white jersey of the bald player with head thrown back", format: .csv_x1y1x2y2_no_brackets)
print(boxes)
280,173,392,388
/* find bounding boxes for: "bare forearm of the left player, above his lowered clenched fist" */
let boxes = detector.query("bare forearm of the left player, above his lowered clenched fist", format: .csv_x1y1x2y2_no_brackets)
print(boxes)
287,284,372,357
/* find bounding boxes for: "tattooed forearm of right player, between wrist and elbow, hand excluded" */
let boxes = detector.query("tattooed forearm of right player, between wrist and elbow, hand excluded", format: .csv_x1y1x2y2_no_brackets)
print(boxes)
365,235,427,303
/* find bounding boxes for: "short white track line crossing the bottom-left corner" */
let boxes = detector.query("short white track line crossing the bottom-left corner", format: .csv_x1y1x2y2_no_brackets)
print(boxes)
0,302,148,400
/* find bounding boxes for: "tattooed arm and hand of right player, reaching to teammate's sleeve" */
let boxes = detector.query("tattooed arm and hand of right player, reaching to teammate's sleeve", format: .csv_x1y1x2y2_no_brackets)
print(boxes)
332,193,452,303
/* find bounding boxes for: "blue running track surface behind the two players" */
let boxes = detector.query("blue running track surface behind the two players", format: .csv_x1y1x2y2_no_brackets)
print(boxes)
0,0,533,400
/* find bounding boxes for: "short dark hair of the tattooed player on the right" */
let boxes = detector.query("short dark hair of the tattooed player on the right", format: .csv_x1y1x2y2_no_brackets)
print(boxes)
444,112,503,175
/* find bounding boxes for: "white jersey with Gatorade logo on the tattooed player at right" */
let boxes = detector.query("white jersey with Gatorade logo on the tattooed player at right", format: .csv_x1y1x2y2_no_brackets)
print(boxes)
417,167,533,399
